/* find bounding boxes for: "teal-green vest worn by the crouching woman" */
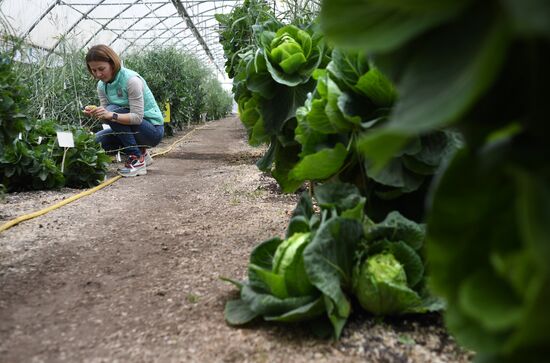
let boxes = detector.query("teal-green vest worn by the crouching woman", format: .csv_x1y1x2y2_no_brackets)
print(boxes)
97,67,164,125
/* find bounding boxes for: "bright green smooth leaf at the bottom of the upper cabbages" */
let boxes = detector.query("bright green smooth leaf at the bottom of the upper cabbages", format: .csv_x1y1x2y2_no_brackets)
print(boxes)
290,144,348,180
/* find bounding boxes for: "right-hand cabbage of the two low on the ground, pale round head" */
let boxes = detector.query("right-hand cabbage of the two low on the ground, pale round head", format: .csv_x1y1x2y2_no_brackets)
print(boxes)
353,212,443,315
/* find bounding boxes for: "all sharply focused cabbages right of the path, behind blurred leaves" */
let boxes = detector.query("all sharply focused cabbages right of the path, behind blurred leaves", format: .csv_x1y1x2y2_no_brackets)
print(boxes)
215,1,452,337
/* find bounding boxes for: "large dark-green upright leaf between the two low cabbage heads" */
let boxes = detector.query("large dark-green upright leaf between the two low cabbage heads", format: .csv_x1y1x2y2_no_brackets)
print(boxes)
304,217,363,328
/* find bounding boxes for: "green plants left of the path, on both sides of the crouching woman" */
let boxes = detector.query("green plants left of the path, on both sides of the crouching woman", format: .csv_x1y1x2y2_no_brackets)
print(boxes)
0,37,232,192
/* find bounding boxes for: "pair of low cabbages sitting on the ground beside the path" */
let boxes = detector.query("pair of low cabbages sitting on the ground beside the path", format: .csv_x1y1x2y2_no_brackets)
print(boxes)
225,184,442,338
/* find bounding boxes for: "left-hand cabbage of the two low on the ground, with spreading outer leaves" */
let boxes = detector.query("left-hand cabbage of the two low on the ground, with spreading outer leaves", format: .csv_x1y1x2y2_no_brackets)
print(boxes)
225,184,365,338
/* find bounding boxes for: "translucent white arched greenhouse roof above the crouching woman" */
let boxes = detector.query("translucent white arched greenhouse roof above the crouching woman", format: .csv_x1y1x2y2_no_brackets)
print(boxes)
0,0,282,77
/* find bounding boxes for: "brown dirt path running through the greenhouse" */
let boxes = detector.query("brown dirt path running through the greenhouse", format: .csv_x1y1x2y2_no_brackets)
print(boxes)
0,118,470,363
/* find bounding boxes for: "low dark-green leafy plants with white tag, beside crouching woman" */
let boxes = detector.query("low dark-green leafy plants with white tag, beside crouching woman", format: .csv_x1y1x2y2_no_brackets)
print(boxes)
0,47,110,191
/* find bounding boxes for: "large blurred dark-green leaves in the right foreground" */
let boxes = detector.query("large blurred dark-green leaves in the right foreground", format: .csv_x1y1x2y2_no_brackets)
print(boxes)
321,0,550,362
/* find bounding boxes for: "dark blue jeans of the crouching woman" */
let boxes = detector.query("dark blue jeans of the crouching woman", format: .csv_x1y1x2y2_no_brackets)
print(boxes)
95,105,164,157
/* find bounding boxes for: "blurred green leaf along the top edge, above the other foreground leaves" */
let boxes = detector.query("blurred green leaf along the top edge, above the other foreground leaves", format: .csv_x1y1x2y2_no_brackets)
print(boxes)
321,0,470,52
